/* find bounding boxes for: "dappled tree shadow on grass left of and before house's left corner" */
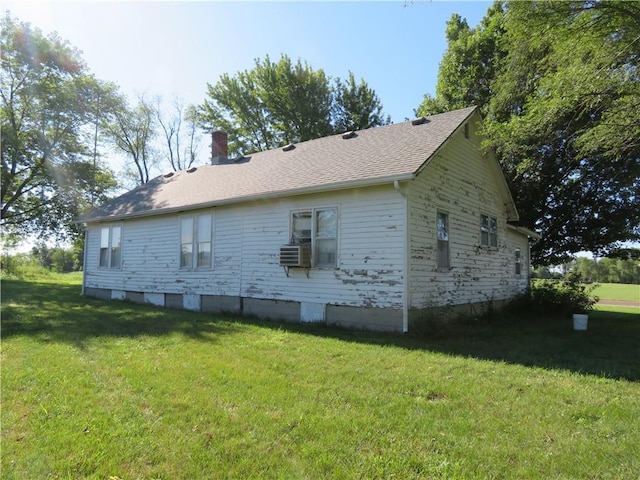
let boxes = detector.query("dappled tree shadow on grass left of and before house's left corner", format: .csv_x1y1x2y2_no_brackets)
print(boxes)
2,280,242,348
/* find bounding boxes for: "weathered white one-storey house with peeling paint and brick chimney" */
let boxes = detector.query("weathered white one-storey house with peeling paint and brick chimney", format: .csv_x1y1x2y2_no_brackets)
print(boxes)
79,108,537,332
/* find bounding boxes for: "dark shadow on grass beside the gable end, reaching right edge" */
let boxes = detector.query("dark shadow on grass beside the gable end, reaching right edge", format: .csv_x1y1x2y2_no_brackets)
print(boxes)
272,311,640,382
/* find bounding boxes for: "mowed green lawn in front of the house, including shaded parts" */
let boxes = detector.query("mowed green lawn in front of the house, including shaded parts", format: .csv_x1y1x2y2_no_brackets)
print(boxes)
1,277,640,480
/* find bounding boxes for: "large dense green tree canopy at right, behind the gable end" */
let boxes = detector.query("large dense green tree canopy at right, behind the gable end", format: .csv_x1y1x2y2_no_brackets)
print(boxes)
417,1,640,264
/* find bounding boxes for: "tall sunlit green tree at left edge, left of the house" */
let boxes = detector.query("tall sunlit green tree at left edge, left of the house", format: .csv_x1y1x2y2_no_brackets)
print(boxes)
0,13,120,237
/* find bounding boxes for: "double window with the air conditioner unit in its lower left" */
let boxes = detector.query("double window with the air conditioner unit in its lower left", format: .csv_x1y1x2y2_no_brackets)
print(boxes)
291,208,338,268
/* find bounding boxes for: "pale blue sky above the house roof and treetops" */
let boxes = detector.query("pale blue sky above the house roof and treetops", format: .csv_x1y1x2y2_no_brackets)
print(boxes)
3,0,491,122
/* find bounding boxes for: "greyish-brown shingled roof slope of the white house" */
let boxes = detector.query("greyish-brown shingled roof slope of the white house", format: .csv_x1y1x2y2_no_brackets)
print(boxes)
78,107,475,222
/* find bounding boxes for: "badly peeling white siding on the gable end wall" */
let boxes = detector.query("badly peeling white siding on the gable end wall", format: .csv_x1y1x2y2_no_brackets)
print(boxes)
409,121,528,308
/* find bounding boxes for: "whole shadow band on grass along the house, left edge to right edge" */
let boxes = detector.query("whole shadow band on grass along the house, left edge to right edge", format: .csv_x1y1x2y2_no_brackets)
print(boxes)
2,281,640,382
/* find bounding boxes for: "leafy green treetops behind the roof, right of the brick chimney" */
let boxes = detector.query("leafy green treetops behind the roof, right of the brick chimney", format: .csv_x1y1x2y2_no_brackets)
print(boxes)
199,55,389,153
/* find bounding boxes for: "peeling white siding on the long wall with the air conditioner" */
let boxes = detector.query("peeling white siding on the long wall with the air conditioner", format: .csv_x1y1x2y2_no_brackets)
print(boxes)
85,184,405,308
